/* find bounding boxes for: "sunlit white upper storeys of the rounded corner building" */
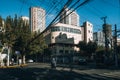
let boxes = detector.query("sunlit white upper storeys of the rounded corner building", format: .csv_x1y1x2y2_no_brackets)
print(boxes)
44,23,83,53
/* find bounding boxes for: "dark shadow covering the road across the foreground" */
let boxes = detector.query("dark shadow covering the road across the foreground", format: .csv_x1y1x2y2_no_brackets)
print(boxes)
0,68,120,80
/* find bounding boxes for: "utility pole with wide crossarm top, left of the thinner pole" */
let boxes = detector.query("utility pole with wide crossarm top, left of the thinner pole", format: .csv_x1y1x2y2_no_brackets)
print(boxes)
101,16,109,63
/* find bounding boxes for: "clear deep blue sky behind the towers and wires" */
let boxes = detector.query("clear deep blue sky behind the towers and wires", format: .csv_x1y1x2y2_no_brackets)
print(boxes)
0,0,120,32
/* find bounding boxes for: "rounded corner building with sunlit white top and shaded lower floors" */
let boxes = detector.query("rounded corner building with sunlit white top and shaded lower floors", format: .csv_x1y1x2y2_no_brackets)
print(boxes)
43,23,93,62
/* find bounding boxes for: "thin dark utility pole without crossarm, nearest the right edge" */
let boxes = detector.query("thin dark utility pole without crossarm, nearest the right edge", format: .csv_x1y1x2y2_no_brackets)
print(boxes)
114,24,118,67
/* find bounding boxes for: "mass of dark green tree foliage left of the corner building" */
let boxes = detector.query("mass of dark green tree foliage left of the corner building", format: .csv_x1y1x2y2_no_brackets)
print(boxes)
0,15,46,58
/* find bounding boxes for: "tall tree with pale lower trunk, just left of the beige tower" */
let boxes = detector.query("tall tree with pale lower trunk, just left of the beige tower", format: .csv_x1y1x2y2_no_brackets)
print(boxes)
14,18,31,64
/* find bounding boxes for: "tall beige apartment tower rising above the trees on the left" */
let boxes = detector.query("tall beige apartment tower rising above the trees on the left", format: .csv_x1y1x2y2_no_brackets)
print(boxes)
30,7,45,33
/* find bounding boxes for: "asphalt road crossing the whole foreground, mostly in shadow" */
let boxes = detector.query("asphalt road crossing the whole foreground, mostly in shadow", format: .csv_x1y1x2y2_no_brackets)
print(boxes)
0,63,120,80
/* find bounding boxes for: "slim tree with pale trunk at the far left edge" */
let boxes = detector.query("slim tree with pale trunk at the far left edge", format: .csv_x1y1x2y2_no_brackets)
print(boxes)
2,16,15,66
